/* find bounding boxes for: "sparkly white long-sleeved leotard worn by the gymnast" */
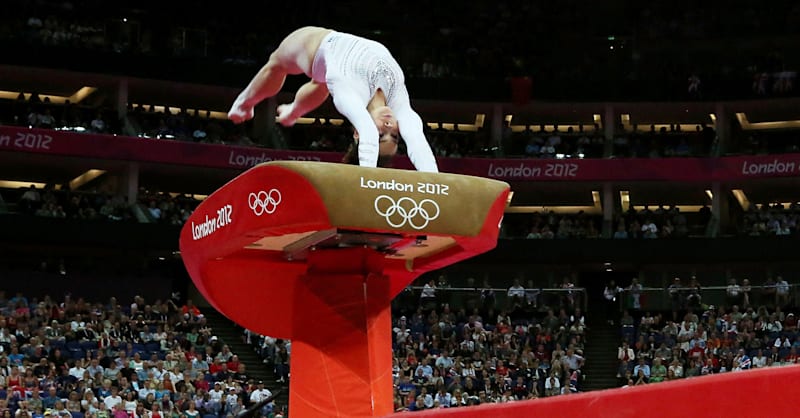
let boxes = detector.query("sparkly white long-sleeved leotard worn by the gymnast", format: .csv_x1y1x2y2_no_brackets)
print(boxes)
311,31,439,172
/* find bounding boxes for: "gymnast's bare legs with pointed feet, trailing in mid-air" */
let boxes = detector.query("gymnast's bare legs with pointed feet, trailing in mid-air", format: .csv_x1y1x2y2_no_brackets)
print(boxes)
228,27,330,123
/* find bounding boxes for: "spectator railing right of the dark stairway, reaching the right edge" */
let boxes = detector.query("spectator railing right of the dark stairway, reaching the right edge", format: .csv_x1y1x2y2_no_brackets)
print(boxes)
620,284,800,312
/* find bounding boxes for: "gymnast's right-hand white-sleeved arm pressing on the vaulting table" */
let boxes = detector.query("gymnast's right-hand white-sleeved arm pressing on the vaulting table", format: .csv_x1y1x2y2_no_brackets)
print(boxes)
392,86,439,173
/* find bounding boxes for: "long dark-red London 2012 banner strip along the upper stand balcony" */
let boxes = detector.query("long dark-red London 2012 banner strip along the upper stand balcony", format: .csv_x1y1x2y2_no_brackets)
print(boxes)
0,126,800,182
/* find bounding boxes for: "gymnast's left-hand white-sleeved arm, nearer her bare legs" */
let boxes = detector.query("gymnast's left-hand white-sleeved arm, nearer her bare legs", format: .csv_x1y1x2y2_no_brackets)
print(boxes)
329,86,380,167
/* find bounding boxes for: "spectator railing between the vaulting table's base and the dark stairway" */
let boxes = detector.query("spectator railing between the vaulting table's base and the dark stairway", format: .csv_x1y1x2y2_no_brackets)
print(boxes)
395,286,588,314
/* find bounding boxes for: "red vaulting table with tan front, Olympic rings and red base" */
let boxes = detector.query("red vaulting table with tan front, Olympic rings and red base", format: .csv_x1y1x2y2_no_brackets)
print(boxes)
180,162,509,417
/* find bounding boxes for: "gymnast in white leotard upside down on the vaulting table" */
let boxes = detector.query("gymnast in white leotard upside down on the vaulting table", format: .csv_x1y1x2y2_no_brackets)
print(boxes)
228,26,439,173
